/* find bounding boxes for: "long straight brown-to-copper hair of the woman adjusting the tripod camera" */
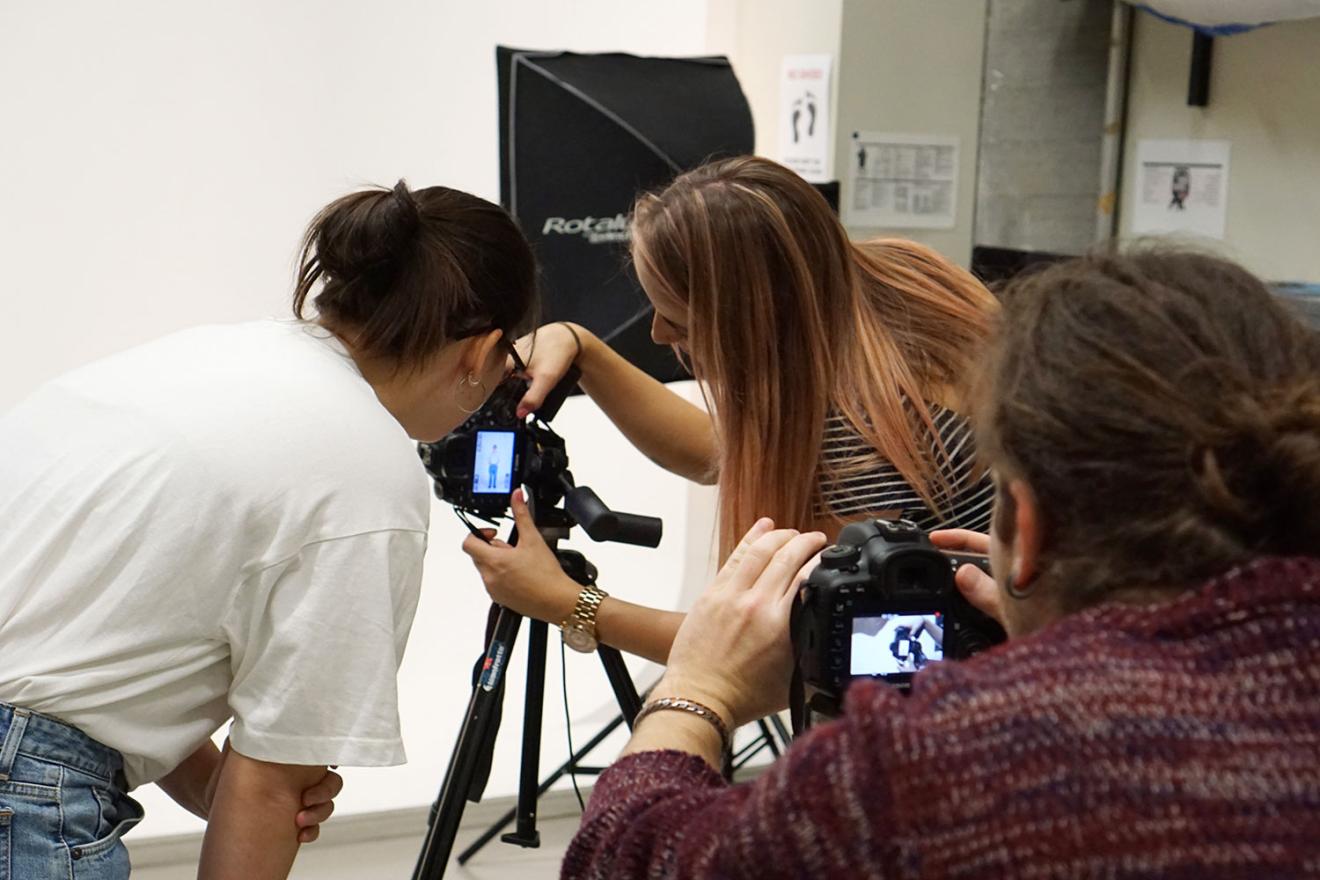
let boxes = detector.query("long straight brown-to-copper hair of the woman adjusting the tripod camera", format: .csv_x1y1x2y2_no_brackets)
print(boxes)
632,157,997,558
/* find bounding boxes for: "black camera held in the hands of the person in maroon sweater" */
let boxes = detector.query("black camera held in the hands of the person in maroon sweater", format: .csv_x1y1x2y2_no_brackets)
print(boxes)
792,520,1005,715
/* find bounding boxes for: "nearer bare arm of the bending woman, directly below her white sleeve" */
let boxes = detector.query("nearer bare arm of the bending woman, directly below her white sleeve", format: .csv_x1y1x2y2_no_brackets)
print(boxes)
198,753,325,880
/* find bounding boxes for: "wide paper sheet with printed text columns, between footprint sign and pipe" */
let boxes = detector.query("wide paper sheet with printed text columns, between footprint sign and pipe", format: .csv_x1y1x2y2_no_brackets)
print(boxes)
845,132,958,230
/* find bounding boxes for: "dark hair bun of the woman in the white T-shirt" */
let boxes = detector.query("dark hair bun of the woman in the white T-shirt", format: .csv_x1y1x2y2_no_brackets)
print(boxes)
315,179,420,281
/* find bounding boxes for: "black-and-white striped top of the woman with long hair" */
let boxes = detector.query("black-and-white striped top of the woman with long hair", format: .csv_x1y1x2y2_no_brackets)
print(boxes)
816,404,994,532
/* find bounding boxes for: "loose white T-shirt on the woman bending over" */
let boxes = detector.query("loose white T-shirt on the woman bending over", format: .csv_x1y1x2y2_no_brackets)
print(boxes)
0,321,430,786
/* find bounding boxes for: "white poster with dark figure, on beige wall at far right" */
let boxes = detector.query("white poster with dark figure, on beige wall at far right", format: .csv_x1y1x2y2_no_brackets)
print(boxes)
1133,140,1229,239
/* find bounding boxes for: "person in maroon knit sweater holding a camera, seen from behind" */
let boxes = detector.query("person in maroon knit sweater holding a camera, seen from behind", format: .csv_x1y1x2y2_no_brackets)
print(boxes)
562,252,1320,880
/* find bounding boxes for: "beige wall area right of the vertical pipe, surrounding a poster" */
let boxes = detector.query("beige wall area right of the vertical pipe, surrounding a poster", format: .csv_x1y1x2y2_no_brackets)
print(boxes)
1121,13,1320,282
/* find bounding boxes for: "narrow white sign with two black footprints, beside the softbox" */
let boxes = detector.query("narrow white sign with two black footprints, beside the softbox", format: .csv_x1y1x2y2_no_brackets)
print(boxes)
779,55,833,183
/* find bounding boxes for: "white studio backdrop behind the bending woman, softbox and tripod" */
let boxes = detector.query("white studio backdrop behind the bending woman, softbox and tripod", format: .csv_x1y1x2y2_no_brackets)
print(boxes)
0,0,709,838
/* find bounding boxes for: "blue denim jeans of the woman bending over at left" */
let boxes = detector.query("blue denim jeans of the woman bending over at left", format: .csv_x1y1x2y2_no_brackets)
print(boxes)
0,703,143,880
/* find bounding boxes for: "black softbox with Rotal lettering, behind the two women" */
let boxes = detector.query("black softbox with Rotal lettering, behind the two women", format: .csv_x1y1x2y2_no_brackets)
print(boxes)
495,46,754,381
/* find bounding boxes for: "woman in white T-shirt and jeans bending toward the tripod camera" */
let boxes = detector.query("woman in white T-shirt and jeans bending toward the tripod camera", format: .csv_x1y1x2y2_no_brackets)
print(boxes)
0,181,536,880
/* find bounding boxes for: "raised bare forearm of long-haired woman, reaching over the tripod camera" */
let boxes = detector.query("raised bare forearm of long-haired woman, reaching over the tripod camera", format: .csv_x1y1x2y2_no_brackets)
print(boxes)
577,329,718,484
